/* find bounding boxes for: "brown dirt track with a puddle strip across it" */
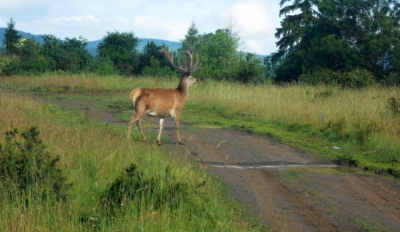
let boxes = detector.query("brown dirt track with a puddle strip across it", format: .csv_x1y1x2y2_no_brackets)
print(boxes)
42,97,400,231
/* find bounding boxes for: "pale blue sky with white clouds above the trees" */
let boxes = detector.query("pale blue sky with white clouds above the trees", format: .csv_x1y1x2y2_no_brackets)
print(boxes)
0,0,282,55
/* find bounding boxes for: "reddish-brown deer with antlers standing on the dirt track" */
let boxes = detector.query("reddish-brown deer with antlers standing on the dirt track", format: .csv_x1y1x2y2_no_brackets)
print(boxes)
127,46,200,145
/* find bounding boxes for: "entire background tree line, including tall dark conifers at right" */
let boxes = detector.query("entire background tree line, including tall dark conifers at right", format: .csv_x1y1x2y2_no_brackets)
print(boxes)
2,0,400,87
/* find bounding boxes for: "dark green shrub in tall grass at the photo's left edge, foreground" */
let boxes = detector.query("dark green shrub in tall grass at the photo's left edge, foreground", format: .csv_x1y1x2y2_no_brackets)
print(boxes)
0,126,71,204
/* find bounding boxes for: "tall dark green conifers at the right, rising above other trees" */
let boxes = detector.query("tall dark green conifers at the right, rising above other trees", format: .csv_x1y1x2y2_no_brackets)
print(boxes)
273,0,400,83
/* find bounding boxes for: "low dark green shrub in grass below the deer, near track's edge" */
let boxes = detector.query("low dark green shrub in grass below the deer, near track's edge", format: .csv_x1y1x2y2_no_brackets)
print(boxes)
100,164,209,220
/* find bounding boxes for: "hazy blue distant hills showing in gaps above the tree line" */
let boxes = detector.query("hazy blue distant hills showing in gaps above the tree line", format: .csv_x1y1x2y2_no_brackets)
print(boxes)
0,27,265,59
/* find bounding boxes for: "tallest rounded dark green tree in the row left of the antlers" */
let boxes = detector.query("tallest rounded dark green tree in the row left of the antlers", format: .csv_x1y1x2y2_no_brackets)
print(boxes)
97,32,139,75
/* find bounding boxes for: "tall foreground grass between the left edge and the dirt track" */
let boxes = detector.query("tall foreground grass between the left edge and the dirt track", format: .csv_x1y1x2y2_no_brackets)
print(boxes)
0,91,259,231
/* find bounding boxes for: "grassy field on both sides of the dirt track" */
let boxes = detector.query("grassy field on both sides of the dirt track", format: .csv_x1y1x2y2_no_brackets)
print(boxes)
0,74,400,231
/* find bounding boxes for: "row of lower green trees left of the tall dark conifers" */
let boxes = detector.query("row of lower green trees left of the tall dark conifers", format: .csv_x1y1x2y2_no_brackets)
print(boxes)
2,19,265,83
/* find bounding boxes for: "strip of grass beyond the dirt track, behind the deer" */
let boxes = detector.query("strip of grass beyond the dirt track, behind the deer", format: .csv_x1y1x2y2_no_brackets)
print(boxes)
1,74,400,177
